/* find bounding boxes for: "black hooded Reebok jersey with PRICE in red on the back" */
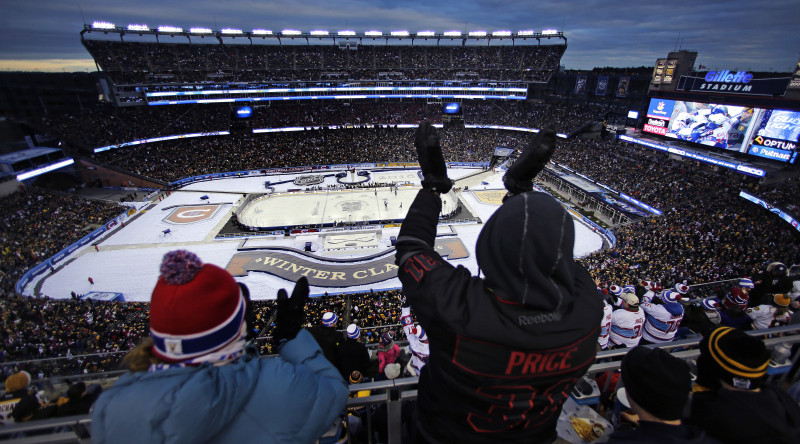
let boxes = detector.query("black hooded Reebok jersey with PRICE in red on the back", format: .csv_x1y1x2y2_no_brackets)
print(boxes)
397,190,603,443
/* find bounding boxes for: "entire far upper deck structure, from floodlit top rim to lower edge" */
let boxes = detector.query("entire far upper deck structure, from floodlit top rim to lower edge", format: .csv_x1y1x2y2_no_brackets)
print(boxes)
81,25,567,102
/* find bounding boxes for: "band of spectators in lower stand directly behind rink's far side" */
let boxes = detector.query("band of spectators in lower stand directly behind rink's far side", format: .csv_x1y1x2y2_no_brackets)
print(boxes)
90,127,525,182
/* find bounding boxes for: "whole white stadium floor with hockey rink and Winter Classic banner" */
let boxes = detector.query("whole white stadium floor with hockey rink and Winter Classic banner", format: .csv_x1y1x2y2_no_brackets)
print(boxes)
29,168,603,301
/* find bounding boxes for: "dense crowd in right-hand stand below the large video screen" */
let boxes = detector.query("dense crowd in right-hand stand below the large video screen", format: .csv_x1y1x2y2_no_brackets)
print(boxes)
553,139,800,285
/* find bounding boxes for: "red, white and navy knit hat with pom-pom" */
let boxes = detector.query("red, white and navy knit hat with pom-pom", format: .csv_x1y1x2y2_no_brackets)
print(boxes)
150,250,246,362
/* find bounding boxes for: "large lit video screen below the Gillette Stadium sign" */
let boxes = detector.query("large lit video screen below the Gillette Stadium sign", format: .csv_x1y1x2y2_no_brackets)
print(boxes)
643,98,800,163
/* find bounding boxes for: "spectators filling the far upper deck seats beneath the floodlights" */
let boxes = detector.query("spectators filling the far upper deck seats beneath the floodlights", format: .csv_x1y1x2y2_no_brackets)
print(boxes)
83,40,566,84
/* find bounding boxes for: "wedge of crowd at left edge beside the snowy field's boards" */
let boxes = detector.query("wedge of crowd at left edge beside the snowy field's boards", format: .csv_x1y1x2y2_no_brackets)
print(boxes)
0,187,126,294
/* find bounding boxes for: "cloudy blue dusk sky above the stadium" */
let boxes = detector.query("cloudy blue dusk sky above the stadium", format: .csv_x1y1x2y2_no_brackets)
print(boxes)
0,0,800,71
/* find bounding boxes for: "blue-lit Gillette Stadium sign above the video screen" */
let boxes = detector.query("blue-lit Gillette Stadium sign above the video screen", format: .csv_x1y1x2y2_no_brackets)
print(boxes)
678,70,791,96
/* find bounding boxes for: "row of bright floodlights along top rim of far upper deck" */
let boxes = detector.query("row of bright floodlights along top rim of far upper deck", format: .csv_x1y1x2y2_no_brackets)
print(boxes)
81,21,567,45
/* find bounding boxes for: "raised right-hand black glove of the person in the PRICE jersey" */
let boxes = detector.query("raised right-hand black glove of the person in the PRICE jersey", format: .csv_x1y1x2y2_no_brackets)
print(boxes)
503,125,556,194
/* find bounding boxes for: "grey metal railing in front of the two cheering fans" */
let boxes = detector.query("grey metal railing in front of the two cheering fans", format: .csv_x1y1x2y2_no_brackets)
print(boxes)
0,324,800,444
